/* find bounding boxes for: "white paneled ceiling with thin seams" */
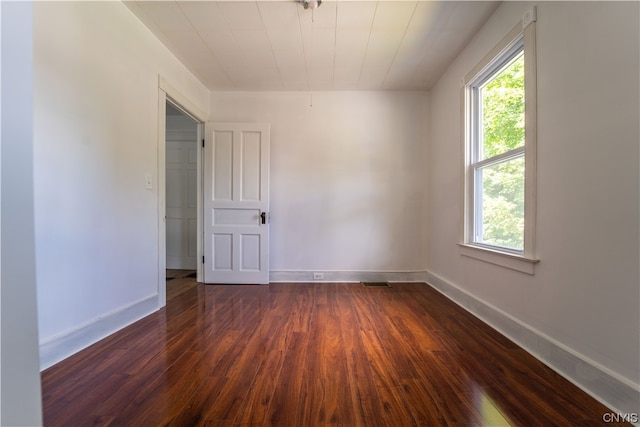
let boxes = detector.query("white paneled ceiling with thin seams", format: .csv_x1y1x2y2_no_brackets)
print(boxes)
124,0,499,91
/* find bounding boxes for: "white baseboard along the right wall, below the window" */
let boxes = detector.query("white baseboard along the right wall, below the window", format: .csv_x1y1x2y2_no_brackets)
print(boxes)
427,273,640,414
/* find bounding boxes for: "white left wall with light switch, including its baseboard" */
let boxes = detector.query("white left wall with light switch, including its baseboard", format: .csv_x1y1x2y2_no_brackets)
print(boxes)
34,2,209,367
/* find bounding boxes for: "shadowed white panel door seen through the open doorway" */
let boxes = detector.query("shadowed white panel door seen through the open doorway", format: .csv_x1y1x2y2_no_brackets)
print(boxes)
166,138,198,270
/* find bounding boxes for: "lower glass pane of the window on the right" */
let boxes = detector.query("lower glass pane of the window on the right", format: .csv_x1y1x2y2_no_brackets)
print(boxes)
475,156,524,251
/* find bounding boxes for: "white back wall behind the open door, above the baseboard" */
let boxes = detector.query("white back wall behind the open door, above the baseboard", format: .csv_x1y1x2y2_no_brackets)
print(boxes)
210,92,428,281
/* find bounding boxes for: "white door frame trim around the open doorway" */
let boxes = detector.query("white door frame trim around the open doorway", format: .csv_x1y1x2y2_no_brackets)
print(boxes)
156,76,207,308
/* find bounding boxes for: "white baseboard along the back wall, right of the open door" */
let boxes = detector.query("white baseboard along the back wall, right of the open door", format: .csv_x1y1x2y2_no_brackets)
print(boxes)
269,270,427,283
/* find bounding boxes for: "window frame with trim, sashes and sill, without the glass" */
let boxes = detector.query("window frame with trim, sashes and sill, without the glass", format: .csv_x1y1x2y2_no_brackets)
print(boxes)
459,14,539,274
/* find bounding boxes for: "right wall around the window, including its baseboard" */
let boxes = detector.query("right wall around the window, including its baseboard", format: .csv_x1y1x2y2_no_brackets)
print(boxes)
429,2,640,412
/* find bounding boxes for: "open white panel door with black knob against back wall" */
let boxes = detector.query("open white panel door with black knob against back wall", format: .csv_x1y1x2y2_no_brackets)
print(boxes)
204,123,269,284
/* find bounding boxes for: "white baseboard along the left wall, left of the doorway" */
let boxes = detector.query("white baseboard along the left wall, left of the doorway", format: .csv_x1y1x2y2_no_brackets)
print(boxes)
40,294,158,371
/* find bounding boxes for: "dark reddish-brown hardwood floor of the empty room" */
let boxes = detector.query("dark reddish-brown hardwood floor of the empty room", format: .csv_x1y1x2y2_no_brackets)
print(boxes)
42,274,624,427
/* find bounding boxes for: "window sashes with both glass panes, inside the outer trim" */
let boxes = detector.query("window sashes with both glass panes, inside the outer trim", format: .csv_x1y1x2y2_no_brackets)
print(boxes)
469,42,525,253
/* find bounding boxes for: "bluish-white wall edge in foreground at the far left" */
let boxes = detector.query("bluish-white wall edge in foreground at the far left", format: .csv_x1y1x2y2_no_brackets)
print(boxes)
0,2,42,426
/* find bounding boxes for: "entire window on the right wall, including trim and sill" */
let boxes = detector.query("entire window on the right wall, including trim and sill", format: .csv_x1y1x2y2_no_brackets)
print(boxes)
461,13,537,274
